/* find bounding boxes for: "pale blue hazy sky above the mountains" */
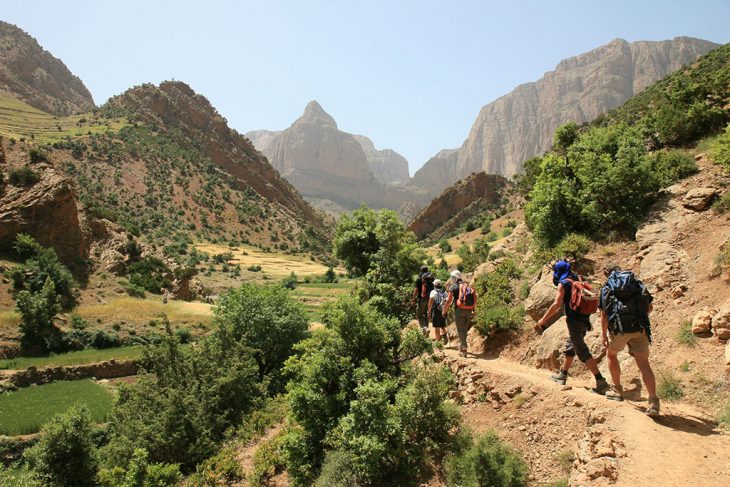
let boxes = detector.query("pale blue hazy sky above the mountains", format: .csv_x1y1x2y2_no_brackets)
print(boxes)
0,0,730,173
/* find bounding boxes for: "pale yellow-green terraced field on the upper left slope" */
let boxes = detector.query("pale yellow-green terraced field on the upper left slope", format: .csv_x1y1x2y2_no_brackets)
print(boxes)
0,94,127,144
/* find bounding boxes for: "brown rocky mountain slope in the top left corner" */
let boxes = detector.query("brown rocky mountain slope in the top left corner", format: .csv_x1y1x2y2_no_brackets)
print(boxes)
0,21,94,116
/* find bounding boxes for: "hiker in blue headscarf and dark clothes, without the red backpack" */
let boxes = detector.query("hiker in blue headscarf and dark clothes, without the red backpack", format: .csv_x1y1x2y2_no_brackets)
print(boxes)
535,260,610,394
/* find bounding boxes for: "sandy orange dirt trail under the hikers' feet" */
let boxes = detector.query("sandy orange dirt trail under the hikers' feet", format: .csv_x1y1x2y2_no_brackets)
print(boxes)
446,350,730,486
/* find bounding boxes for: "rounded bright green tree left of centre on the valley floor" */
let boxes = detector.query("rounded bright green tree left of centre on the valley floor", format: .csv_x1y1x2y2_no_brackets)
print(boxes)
214,278,309,392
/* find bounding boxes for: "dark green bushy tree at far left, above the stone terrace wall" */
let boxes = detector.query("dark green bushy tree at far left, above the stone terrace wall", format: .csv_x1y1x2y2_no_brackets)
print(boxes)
15,277,61,352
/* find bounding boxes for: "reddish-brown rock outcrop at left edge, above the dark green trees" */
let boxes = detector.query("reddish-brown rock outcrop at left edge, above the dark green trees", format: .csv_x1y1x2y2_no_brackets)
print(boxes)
0,165,88,264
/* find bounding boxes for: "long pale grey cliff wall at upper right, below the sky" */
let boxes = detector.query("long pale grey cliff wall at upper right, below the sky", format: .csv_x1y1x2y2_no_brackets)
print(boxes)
412,37,717,192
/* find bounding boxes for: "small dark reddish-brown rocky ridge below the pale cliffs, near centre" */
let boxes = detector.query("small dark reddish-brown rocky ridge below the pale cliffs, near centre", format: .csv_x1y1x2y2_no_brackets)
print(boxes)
408,172,509,239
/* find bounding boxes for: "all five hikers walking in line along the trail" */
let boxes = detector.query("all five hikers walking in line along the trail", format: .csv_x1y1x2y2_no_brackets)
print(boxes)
411,260,660,416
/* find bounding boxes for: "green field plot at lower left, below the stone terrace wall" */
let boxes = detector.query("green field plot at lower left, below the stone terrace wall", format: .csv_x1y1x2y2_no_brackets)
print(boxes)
0,380,113,435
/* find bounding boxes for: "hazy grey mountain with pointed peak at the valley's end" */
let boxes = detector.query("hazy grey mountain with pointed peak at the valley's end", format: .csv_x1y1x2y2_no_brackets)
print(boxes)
246,101,427,215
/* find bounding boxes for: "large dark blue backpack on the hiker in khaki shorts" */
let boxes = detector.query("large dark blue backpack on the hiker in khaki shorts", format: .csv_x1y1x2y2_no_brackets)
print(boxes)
603,271,651,341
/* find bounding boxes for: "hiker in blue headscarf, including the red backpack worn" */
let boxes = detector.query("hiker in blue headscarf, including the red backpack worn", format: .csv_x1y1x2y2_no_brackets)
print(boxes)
535,260,610,394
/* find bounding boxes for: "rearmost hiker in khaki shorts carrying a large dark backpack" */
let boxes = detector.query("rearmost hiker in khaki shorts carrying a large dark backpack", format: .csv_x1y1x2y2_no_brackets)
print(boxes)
598,262,659,416
